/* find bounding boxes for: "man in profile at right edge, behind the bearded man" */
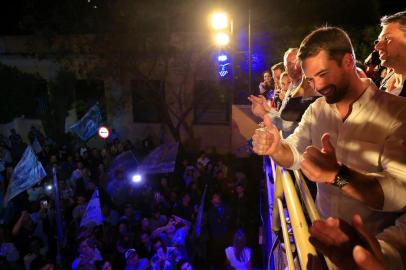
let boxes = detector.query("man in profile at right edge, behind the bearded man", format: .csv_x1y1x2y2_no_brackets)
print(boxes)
375,10,406,97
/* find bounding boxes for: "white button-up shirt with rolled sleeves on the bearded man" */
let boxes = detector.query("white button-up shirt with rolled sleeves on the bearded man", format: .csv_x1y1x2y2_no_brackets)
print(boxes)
285,79,406,233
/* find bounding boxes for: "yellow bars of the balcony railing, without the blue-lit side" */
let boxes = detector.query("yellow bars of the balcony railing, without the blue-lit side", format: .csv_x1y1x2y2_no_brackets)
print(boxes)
268,157,330,269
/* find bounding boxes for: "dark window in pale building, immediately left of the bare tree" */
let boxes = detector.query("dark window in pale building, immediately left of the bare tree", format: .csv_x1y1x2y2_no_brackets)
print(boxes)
131,80,165,123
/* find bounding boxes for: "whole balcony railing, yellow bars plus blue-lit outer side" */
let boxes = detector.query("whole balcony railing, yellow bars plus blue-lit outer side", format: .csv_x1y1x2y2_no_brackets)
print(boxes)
264,157,334,269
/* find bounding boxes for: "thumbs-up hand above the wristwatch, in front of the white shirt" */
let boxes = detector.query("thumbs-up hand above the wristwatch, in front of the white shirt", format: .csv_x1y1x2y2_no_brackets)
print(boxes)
300,133,340,183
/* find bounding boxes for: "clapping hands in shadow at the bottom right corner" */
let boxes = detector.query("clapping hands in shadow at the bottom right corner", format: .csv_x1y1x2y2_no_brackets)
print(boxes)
310,214,406,270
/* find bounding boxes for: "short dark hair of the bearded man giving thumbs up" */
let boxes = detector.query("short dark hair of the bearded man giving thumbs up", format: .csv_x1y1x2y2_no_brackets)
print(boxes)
297,27,355,65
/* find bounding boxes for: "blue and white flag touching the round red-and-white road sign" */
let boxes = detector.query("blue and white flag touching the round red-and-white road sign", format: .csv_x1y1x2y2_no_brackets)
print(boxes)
69,104,103,141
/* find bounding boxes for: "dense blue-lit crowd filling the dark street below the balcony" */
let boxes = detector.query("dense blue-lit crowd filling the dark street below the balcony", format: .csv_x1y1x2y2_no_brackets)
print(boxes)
0,127,261,270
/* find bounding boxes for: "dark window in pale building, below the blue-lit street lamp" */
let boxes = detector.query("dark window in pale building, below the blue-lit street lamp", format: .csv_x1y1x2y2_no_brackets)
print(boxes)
194,81,230,125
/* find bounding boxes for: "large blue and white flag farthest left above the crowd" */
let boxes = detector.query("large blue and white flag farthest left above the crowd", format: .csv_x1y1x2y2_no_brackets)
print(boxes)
6,146,47,203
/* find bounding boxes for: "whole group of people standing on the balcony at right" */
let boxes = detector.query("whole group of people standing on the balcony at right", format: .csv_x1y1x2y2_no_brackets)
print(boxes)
249,11,406,269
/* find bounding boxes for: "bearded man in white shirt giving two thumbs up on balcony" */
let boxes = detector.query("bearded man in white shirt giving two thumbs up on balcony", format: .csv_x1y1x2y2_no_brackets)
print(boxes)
253,27,406,233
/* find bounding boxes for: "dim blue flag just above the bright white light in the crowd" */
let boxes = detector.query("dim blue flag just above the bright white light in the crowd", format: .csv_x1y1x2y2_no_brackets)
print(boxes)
138,143,179,174
